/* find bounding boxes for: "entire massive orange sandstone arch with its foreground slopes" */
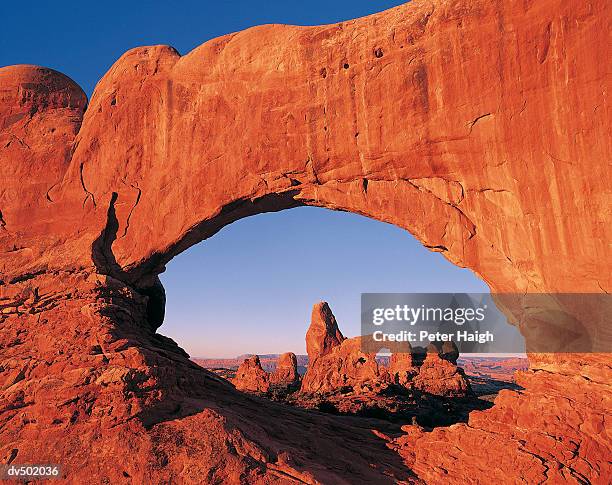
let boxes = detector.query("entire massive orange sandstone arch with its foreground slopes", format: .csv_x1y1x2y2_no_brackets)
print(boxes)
0,0,612,483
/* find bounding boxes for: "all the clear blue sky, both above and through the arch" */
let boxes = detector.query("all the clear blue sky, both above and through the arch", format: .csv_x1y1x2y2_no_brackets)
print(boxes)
0,0,488,357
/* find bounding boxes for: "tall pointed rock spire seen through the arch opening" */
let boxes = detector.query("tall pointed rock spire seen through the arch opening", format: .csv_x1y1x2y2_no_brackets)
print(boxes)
306,301,344,362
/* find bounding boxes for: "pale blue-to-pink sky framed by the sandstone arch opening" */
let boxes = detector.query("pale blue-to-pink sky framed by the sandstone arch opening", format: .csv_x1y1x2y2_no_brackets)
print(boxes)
153,207,524,416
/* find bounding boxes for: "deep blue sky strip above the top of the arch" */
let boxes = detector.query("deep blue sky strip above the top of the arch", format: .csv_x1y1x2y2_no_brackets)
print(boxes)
0,0,405,96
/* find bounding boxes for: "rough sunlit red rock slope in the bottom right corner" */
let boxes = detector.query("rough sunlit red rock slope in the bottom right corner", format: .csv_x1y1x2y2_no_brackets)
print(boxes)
396,364,612,484
